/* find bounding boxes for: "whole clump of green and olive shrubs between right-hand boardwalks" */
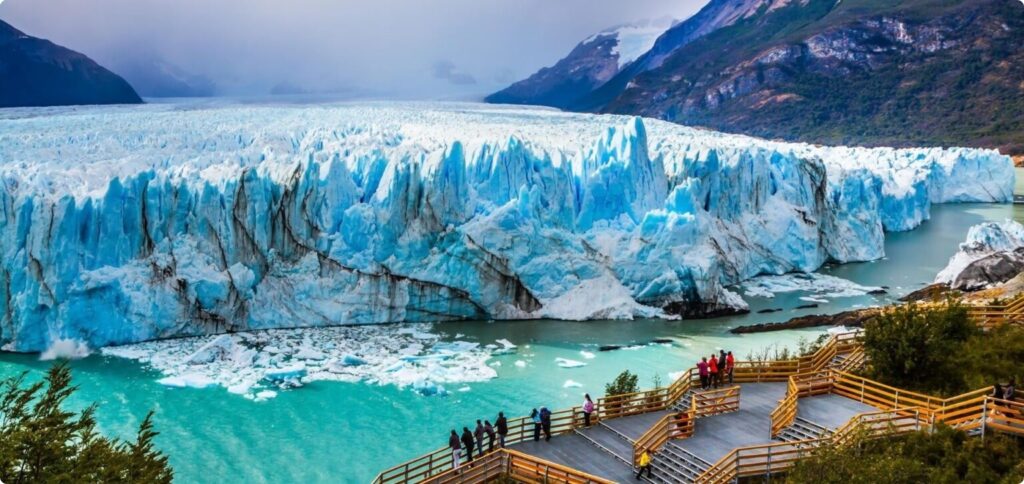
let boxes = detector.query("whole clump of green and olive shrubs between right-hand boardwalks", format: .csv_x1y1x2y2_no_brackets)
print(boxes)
864,302,1024,396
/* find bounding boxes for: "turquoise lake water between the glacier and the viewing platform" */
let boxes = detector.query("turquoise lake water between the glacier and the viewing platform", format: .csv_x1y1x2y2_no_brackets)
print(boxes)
0,200,1024,482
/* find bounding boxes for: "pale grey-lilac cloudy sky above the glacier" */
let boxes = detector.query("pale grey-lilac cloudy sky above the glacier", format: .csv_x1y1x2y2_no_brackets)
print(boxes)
0,0,707,99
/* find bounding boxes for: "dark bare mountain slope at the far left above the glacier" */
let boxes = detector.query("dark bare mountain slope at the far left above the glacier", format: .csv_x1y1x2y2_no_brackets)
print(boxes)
0,20,142,107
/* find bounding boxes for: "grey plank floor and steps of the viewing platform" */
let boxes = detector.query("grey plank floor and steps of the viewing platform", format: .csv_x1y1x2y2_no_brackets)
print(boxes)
503,383,876,482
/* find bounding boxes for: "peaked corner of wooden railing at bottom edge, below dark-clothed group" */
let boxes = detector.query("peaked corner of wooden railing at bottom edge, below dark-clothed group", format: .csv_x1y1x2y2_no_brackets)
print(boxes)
424,449,613,484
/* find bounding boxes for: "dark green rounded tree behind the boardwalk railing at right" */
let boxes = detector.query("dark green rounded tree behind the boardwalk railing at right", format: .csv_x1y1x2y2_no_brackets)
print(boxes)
864,300,981,394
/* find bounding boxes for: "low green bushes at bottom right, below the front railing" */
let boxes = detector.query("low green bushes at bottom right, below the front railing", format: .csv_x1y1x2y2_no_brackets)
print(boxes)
785,426,1024,484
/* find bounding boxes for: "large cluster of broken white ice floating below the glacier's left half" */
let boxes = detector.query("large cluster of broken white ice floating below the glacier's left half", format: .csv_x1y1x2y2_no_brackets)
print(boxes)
100,324,498,400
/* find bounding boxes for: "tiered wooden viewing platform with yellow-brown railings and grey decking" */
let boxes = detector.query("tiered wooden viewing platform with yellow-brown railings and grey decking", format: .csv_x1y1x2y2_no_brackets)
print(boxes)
373,298,1024,484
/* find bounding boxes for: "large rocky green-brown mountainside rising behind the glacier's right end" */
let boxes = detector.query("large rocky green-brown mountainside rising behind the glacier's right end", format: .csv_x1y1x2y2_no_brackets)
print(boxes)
599,0,1024,152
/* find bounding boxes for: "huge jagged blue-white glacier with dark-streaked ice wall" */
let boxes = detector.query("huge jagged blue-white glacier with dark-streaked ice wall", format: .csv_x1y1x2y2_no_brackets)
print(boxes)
0,104,1014,351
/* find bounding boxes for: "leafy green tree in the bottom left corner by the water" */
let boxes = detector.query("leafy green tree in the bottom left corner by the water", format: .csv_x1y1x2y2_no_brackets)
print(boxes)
0,363,174,484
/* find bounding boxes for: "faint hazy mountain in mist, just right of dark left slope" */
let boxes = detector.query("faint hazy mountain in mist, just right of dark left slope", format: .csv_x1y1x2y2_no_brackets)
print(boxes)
109,54,217,97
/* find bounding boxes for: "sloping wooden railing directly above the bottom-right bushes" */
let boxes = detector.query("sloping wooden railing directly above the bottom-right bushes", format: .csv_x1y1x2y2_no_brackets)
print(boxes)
694,407,922,484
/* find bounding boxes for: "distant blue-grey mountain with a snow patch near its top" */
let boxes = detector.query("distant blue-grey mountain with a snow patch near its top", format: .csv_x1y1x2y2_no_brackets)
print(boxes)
486,18,673,108
